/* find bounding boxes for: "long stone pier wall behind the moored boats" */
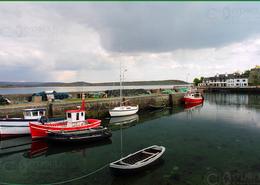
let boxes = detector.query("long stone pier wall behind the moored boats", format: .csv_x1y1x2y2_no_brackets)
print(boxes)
0,93,184,118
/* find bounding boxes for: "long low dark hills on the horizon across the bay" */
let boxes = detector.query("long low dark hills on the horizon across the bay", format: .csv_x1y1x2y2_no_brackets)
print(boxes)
0,80,187,88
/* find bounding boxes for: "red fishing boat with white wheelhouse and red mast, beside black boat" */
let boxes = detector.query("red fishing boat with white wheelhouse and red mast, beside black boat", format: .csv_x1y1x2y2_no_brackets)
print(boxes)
30,99,101,139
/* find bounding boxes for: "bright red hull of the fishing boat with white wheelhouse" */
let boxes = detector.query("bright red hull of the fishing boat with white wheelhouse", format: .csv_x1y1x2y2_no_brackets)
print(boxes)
30,119,101,139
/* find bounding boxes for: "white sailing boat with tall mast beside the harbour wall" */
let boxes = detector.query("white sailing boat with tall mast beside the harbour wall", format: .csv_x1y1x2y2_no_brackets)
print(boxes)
109,62,139,117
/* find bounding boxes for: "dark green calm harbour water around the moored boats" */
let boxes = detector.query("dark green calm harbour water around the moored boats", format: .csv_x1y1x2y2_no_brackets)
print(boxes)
0,94,260,185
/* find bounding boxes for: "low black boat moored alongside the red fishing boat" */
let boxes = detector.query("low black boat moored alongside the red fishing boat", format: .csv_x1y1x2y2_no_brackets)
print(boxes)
47,126,112,143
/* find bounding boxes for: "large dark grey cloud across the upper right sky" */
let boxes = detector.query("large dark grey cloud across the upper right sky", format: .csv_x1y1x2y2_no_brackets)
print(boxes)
50,3,260,52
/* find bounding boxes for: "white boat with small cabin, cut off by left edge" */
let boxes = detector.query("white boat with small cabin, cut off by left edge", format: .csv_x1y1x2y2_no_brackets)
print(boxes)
0,108,46,139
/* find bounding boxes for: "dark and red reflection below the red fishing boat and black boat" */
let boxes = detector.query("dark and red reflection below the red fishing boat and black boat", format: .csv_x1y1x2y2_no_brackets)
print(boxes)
23,139,112,159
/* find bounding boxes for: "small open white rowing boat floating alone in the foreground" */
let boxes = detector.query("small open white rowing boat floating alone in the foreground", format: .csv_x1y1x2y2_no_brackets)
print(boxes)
109,145,165,173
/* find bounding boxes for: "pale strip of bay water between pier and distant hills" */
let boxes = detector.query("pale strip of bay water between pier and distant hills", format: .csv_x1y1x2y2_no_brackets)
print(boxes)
0,85,187,94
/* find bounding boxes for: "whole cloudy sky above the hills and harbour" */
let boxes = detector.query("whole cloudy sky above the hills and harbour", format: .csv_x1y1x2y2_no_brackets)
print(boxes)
0,2,260,82
